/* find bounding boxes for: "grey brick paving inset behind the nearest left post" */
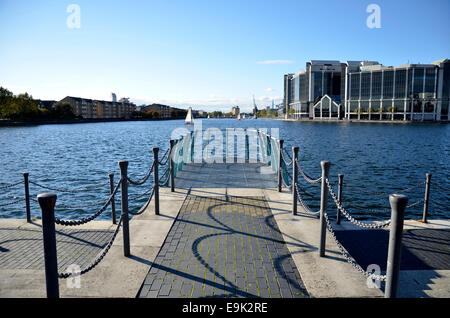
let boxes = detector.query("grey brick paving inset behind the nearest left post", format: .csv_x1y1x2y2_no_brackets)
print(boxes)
0,228,113,271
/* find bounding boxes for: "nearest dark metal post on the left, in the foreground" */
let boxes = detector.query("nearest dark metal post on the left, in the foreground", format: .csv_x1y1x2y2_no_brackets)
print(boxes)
37,193,59,298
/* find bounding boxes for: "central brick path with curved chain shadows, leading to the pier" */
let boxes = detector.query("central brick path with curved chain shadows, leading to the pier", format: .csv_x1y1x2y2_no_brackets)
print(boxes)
138,196,308,297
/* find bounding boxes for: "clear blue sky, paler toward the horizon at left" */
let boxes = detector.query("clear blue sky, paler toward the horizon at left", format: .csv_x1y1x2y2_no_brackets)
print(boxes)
0,0,450,111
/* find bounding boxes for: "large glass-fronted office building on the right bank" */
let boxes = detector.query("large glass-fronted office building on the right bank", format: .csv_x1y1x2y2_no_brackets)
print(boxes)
283,59,450,121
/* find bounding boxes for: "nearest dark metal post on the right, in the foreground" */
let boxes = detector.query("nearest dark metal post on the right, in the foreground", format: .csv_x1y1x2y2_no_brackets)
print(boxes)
384,194,408,298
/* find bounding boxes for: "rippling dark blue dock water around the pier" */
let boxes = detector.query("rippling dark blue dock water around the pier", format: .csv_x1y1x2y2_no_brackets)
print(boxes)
0,119,450,219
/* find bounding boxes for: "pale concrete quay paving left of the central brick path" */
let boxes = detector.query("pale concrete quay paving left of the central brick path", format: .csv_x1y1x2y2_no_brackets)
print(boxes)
0,188,186,298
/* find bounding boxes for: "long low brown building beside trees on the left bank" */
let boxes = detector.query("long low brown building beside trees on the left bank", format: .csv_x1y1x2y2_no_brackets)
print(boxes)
60,96,136,119
